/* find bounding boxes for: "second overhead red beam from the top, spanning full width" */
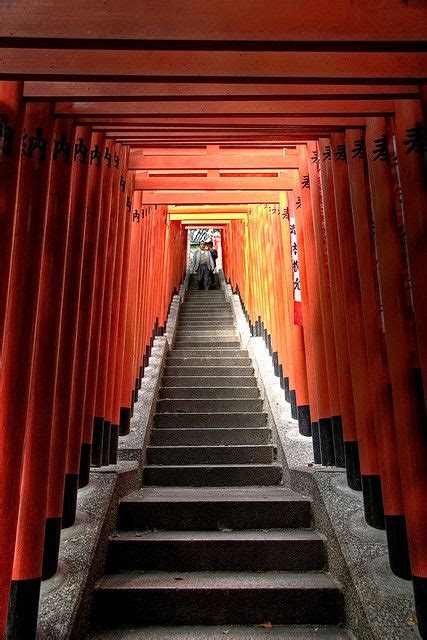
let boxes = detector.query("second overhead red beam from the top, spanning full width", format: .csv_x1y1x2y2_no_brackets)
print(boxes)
0,50,427,84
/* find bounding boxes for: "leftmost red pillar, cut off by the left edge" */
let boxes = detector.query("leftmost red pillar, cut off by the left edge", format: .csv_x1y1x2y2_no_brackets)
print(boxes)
0,80,24,351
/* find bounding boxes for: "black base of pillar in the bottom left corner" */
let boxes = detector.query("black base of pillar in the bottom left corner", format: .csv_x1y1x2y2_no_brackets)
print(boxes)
6,578,41,640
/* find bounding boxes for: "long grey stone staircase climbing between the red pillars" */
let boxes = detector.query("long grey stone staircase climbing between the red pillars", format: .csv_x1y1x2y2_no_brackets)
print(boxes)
91,290,347,640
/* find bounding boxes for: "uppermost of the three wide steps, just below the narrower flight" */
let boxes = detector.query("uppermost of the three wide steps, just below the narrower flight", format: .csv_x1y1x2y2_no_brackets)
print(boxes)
119,486,311,531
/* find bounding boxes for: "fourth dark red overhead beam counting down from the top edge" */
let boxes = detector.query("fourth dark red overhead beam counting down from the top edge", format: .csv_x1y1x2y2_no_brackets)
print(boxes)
55,99,398,119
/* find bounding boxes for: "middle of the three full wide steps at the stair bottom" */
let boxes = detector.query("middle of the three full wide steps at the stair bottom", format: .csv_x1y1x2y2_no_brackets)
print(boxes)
108,530,326,572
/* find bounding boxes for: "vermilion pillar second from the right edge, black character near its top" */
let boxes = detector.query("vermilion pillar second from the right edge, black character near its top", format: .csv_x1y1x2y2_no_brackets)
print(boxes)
366,118,427,635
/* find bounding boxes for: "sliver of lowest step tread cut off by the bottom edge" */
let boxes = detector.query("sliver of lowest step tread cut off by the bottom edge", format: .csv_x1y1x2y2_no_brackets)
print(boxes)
88,625,349,640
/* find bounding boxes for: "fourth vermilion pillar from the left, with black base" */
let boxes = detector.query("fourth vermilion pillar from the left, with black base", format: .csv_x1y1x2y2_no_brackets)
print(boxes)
42,126,92,579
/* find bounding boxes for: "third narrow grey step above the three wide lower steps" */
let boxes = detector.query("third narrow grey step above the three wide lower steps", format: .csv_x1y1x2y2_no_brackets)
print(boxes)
150,427,271,446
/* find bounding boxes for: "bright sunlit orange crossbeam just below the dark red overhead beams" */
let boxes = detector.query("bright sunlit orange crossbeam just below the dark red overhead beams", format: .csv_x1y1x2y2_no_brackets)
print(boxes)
129,150,298,171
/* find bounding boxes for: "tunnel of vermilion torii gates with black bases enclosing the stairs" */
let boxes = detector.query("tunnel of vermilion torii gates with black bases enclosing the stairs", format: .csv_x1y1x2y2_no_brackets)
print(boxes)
0,0,427,637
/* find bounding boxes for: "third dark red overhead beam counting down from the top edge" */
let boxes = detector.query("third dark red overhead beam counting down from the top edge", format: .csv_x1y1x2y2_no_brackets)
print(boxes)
24,80,418,100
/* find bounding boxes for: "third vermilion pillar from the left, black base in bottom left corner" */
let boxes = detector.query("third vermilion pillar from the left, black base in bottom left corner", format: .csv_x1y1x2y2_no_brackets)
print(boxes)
7,119,74,638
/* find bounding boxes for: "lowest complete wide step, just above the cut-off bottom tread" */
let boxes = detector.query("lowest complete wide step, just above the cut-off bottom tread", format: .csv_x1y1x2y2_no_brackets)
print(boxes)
94,571,342,625
